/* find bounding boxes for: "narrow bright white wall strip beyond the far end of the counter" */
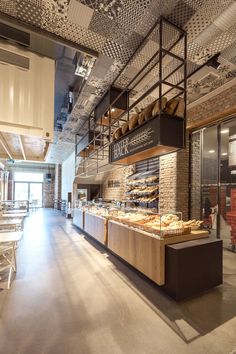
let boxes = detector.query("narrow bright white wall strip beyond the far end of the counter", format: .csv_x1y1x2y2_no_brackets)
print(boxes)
61,152,75,200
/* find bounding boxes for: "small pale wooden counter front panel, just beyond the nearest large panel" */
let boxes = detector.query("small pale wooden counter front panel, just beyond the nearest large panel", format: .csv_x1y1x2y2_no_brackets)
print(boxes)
84,212,107,245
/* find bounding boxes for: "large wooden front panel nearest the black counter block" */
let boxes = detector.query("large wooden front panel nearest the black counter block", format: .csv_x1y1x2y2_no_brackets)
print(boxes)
108,221,165,285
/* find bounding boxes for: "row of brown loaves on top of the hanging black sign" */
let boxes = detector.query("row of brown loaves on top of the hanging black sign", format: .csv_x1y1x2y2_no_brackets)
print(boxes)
113,97,185,140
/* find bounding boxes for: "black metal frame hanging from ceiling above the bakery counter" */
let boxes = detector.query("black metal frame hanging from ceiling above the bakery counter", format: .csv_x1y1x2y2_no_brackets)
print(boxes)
75,17,187,177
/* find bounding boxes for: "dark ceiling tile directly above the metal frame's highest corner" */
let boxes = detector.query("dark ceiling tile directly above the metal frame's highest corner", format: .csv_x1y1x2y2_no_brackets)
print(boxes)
168,1,195,28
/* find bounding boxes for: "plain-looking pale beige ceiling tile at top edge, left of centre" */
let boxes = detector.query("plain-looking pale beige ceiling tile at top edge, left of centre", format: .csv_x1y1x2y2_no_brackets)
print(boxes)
67,0,94,28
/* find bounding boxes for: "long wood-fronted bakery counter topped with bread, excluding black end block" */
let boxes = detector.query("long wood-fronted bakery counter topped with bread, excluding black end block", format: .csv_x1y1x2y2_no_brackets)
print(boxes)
75,204,209,285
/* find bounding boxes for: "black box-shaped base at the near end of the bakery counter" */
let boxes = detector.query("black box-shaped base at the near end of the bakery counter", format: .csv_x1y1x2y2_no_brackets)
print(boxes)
163,239,223,300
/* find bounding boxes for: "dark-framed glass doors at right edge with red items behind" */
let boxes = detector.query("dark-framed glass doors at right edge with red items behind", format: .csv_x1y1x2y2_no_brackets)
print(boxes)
192,119,236,251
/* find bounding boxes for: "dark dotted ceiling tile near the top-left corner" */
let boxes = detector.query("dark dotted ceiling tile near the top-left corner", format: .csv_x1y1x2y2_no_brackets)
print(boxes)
16,0,42,27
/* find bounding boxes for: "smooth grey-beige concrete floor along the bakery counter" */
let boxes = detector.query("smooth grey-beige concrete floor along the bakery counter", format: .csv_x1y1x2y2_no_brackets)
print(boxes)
0,210,236,354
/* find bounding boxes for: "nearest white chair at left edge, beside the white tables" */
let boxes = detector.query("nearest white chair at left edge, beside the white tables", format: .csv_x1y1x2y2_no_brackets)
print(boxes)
0,242,16,289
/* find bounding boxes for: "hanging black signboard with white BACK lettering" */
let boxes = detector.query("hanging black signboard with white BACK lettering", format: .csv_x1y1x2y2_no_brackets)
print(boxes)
109,114,184,163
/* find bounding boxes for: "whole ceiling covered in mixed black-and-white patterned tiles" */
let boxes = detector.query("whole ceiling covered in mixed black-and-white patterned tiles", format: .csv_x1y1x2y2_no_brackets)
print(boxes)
0,0,236,159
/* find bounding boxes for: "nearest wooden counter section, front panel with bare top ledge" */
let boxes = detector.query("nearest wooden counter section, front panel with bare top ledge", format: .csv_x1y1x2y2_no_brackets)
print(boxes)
108,220,209,285
